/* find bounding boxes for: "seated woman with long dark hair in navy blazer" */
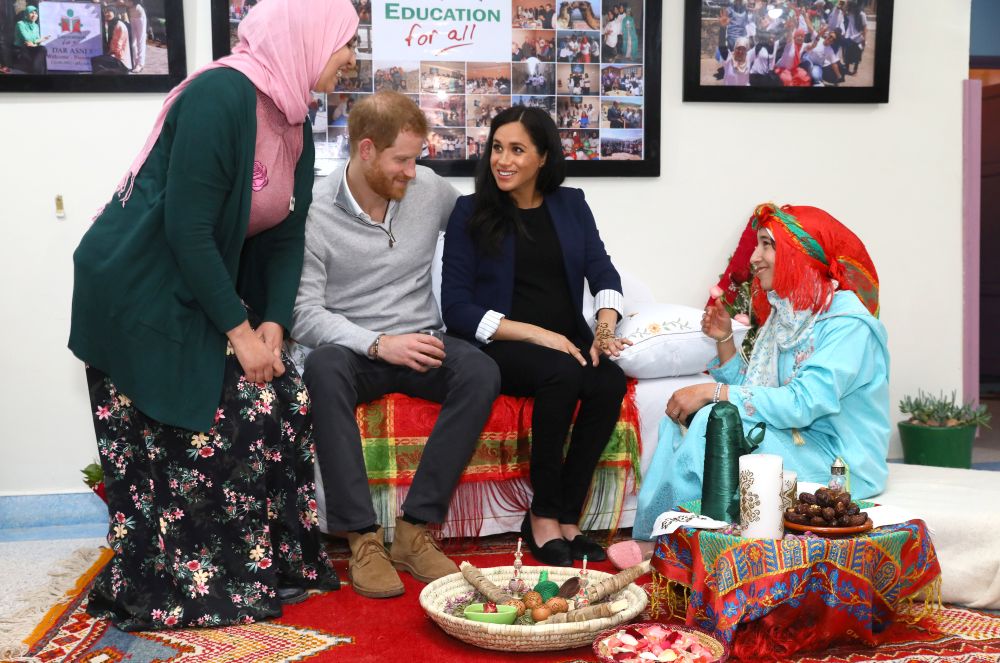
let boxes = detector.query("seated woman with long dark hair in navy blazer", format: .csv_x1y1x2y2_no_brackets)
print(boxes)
441,106,629,566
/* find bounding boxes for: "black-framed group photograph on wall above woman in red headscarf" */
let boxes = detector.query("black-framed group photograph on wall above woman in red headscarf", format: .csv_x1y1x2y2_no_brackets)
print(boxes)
684,0,893,103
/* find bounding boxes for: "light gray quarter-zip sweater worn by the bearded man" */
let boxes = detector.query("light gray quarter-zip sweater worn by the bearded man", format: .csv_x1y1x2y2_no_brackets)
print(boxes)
292,162,459,354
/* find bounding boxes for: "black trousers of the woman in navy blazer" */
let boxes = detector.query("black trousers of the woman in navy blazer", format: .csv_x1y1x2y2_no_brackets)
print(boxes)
485,341,626,525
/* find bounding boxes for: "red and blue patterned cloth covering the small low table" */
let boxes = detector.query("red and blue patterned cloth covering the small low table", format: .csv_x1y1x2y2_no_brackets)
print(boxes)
652,508,941,645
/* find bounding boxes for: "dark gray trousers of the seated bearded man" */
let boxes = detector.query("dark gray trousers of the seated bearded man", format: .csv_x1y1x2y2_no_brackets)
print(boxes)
303,335,500,531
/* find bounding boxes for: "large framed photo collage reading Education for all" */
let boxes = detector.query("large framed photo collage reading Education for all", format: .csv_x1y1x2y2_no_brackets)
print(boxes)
212,0,664,177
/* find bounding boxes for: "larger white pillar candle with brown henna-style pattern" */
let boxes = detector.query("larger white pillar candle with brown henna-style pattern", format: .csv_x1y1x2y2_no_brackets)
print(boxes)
740,454,784,539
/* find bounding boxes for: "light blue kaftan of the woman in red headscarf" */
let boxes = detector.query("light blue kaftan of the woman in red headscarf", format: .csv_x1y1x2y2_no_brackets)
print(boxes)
632,291,890,539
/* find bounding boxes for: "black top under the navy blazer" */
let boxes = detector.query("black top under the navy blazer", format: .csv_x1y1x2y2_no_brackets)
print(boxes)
508,204,579,341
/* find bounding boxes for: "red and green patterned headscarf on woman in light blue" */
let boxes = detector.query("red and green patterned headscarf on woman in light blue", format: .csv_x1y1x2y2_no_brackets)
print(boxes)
750,203,879,324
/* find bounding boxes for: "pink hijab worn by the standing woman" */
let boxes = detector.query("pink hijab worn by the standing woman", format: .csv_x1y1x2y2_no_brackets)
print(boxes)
117,0,358,207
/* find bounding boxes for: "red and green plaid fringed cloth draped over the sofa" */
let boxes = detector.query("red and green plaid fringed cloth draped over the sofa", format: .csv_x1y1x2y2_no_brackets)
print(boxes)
355,380,642,537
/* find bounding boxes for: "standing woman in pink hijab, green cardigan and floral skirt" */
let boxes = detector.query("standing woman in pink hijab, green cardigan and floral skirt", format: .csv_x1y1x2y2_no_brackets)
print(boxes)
69,0,358,631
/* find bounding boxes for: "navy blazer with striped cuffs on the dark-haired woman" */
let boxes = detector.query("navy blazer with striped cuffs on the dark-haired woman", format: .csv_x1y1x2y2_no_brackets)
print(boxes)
441,187,622,345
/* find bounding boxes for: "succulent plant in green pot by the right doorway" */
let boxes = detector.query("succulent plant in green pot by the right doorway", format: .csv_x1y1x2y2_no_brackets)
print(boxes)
899,390,990,469
